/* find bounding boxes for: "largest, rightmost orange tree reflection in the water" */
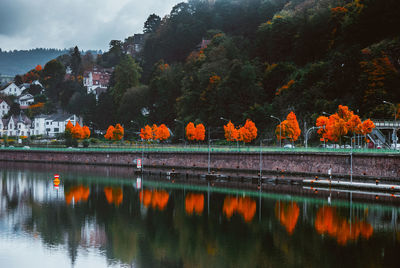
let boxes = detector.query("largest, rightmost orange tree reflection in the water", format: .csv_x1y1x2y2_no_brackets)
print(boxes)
315,206,373,245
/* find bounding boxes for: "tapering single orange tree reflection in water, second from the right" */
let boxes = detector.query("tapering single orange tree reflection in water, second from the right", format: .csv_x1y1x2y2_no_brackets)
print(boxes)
275,201,300,235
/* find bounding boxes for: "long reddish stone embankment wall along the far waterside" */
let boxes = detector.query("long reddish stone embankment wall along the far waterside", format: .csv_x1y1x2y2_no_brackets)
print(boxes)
0,150,400,179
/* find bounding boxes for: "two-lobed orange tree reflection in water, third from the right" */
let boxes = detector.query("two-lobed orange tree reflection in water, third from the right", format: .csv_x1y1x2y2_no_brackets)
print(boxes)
222,196,257,222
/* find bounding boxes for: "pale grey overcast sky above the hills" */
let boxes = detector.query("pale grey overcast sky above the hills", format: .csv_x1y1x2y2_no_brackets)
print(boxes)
0,0,183,51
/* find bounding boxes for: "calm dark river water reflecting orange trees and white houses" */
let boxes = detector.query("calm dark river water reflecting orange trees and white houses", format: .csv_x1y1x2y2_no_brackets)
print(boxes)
0,163,400,268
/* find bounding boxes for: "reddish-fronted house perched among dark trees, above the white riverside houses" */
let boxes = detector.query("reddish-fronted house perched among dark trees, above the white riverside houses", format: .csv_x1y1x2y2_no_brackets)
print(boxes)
83,66,113,99
